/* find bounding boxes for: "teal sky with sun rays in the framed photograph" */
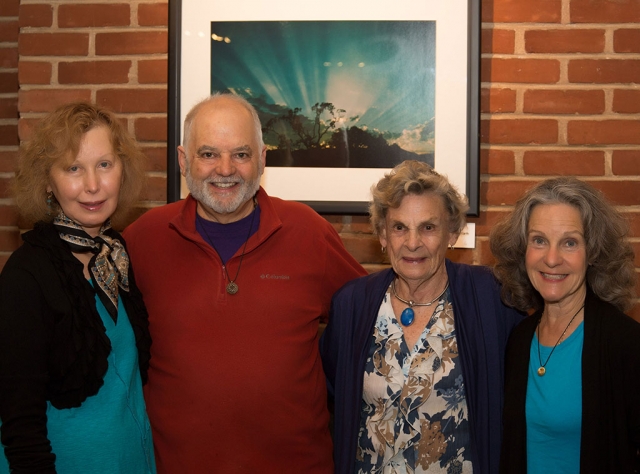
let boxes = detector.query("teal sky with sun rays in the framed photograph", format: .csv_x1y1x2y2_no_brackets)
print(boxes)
211,21,435,153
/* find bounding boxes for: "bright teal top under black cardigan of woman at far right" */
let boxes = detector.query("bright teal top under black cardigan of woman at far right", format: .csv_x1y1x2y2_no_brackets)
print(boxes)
526,323,584,474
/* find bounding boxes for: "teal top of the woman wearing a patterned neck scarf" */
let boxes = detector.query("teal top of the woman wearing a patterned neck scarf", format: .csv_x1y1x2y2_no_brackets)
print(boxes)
0,290,156,474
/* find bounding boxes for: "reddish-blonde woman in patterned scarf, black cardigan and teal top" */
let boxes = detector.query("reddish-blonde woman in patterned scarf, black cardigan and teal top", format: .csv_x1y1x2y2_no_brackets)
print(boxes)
0,103,155,473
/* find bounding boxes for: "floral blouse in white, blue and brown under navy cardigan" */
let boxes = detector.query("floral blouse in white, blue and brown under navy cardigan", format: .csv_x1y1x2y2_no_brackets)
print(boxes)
356,290,472,474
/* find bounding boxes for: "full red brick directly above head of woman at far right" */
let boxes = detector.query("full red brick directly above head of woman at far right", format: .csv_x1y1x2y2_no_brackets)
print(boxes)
523,150,604,176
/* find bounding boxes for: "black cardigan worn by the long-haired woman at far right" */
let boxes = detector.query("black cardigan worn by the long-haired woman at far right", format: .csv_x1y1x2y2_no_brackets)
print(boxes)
500,291,640,474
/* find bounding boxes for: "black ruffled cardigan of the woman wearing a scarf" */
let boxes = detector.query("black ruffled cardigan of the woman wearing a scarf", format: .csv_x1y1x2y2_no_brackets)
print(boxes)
0,223,151,472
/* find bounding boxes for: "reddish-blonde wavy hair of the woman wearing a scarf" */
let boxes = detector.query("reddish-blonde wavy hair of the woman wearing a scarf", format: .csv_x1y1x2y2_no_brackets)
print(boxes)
12,102,145,229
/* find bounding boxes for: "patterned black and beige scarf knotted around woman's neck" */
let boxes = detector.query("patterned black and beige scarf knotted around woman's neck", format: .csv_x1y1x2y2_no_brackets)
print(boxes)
53,210,129,322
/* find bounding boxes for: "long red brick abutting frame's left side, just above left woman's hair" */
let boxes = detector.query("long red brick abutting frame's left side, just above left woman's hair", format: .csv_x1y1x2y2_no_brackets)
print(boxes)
96,89,167,113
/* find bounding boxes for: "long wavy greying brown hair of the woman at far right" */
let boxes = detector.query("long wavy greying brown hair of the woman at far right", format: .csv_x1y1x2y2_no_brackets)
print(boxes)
490,177,636,311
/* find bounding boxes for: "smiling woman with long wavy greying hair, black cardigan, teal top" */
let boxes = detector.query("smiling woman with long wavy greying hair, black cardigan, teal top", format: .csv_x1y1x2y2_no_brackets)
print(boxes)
491,177,640,474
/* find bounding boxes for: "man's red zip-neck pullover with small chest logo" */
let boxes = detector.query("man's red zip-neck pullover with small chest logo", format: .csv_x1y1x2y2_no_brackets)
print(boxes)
124,188,365,474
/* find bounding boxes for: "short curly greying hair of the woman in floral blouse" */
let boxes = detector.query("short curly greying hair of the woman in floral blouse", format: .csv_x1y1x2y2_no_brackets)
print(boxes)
369,160,469,234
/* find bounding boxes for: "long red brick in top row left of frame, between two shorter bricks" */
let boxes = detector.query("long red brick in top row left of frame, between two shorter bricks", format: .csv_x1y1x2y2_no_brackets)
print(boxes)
58,3,131,28
